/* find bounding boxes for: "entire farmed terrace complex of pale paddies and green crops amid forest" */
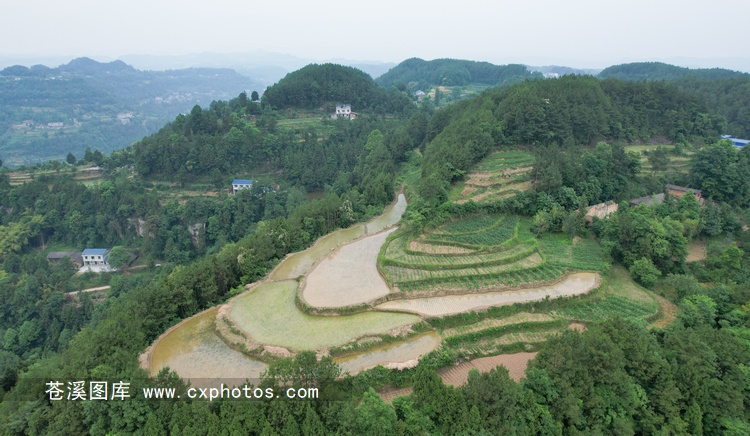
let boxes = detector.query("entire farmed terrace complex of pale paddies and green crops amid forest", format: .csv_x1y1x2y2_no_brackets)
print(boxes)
145,195,672,384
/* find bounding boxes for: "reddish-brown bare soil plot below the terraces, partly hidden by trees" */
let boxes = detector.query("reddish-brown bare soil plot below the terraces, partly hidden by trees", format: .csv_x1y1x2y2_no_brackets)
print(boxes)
380,353,536,403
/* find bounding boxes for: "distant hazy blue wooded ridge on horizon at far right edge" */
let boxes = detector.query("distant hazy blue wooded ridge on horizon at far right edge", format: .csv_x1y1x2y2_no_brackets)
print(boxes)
599,62,750,81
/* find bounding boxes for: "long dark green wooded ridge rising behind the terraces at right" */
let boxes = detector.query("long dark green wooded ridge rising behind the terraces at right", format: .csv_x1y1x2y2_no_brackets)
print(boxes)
423,76,723,198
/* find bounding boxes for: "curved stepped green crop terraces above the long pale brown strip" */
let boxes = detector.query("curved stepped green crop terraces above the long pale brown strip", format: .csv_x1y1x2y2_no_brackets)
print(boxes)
379,215,608,292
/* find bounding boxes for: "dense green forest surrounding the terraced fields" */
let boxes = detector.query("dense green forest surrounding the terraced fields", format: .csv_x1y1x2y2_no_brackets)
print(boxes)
0,63,750,435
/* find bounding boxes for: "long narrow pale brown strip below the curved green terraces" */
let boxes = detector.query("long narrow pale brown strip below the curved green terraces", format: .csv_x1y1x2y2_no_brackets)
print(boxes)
377,273,599,316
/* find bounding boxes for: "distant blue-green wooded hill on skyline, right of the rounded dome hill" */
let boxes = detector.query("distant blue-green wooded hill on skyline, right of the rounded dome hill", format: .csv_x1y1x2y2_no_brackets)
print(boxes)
376,58,541,90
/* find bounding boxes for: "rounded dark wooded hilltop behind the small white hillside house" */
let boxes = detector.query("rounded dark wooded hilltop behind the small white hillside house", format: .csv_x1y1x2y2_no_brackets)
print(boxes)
263,64,411,113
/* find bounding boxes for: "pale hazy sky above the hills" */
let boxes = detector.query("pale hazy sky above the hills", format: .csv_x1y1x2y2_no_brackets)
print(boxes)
0,0,750,69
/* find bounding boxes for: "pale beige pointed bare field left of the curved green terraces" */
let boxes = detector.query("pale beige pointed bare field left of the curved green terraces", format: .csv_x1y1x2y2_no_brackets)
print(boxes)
302,228,396,307
